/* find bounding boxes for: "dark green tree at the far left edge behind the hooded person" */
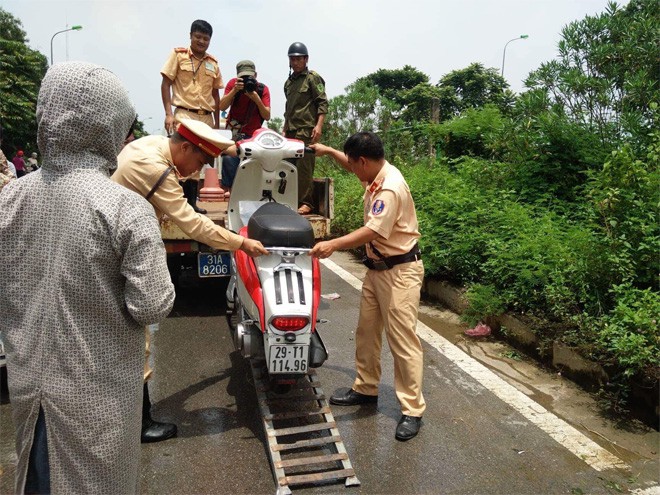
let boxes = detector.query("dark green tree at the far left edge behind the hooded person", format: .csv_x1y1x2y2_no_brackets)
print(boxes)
0,8,48,155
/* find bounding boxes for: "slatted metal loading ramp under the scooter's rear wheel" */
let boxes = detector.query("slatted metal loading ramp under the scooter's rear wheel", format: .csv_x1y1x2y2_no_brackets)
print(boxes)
251,360,360,495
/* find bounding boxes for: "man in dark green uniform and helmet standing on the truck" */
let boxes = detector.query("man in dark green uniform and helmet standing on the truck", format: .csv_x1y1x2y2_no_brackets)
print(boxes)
284,42,328,214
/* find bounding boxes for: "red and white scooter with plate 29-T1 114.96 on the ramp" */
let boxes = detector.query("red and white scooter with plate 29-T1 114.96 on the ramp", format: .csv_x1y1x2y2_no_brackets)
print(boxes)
226,129,328,388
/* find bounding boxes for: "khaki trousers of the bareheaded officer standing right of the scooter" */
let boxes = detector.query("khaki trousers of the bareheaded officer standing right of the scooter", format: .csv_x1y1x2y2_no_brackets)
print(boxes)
353,261,426,417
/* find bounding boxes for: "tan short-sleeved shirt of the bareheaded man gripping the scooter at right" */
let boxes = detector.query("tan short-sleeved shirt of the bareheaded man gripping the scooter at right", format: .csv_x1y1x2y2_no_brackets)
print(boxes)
363,162,420,260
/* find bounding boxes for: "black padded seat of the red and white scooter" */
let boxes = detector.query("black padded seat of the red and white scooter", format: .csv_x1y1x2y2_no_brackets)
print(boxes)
248,202,314,248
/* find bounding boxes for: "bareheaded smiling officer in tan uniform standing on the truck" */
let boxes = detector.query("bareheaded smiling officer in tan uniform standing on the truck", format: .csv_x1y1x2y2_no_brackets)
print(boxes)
160,20,225,213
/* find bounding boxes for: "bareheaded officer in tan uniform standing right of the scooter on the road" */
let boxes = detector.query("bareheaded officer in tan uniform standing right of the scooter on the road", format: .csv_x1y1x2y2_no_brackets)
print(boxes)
310,132,426,441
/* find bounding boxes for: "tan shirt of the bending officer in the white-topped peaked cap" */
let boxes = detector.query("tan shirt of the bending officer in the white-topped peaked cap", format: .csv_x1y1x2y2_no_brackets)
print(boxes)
112,136,243,251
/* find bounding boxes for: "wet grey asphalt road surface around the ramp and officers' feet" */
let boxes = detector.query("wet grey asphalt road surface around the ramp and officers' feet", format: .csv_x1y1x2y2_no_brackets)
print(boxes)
0,254,658,494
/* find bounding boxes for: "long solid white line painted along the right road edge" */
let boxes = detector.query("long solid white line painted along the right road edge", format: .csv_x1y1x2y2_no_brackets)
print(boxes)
321,259,629,471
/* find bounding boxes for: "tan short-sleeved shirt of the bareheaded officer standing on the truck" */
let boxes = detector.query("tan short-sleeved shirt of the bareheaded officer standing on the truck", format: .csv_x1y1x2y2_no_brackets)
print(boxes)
160,48,225,112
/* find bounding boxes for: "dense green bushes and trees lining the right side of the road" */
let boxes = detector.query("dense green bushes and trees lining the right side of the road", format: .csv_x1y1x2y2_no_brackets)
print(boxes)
317,0,660,407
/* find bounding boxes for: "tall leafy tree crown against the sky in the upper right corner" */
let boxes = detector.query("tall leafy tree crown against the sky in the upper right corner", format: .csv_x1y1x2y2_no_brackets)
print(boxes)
525,0,660,148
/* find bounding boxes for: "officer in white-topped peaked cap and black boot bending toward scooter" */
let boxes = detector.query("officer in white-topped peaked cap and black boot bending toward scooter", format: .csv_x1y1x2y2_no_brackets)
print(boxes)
112,119,268,443
